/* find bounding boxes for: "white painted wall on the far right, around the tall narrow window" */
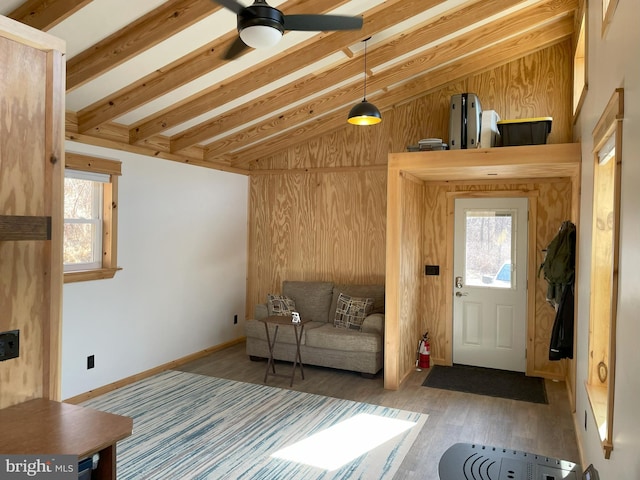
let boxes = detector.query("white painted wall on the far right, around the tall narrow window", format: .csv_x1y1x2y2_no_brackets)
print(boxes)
575,0,640,480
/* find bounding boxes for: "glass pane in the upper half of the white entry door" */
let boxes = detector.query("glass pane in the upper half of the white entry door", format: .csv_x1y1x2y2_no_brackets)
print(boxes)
465,210,514,288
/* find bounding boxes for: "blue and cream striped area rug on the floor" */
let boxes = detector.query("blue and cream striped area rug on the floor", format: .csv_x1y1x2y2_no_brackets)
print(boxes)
83,371,427,480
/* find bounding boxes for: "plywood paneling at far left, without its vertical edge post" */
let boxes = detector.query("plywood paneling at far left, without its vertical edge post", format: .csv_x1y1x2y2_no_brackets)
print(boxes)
0,37,49,407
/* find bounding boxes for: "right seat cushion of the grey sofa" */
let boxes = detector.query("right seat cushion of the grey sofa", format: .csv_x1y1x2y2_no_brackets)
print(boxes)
302,323,382,352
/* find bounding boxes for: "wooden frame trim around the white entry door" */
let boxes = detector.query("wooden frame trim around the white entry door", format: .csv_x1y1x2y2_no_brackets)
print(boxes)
444,190,539,375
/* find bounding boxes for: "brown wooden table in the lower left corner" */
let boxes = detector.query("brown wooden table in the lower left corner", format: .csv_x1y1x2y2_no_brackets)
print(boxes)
0,398,133,480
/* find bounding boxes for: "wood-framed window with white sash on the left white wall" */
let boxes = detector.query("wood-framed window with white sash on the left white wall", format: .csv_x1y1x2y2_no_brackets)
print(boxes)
63,152,121,283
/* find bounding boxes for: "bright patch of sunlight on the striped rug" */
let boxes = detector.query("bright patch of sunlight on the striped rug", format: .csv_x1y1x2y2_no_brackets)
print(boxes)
271,413,415,471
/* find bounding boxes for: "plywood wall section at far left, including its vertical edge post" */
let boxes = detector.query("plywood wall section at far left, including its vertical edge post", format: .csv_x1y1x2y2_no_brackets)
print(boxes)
0,16,64,408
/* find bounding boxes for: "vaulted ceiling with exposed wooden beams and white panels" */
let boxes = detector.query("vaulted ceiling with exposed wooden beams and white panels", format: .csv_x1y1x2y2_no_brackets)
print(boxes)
0,0,577,171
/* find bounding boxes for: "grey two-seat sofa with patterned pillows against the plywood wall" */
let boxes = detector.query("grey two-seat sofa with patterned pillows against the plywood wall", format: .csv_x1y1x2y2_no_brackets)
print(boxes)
245,281,384,377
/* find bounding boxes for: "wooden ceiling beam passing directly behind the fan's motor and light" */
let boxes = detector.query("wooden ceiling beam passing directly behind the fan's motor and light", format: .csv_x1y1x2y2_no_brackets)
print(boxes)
78,0,348,133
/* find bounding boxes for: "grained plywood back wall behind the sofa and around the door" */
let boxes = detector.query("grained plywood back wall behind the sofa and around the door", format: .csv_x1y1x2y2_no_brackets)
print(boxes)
247,41,572,376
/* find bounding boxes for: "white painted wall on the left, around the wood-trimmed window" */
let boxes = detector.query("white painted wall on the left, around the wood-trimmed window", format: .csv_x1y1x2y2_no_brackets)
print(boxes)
62,142,248,399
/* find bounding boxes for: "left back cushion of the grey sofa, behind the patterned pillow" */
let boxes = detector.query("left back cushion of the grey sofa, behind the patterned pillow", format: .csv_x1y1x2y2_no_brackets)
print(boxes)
282,280,333,323
